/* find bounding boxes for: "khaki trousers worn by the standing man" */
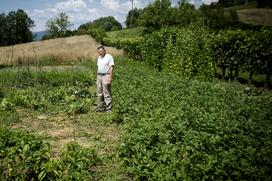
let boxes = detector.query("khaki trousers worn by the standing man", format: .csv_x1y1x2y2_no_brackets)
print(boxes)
96,74,112,111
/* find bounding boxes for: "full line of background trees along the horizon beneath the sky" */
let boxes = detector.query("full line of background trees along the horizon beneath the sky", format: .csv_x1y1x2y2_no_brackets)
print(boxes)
0,0,272,46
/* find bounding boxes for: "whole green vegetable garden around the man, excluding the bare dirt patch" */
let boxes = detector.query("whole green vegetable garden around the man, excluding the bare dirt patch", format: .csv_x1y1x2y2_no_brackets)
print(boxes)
0,57,272,180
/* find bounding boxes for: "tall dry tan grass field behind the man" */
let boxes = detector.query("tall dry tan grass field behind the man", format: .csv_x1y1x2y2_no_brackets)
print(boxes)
0,35,123,65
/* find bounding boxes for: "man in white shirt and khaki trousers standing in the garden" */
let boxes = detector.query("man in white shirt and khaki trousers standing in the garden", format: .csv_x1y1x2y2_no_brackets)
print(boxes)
96,45,114,112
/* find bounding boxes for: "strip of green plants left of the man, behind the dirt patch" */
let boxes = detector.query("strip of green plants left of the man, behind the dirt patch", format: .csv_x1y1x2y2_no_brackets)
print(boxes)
0,68,95,114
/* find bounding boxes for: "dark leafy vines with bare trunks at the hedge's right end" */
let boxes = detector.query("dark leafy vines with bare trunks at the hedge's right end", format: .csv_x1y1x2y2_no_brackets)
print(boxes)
212,28,272,84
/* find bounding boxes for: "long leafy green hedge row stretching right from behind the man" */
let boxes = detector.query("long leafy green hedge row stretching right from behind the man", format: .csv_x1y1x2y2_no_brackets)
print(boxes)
100,27,272,84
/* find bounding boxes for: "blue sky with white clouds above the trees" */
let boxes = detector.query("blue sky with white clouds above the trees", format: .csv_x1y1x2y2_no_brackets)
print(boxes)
0,0,217,32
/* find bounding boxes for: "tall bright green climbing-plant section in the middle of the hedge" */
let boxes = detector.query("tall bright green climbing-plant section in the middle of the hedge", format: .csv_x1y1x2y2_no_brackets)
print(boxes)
163,27,215,79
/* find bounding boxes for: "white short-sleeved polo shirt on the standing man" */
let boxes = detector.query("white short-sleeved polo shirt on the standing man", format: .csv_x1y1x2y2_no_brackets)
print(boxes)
97,54,114,74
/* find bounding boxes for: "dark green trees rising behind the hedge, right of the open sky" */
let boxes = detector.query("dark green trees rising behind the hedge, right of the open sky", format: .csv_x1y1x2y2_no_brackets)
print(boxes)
125,0,271,32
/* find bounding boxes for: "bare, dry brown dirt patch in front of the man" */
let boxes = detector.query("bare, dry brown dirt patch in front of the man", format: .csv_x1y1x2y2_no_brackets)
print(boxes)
12,109,120,157
